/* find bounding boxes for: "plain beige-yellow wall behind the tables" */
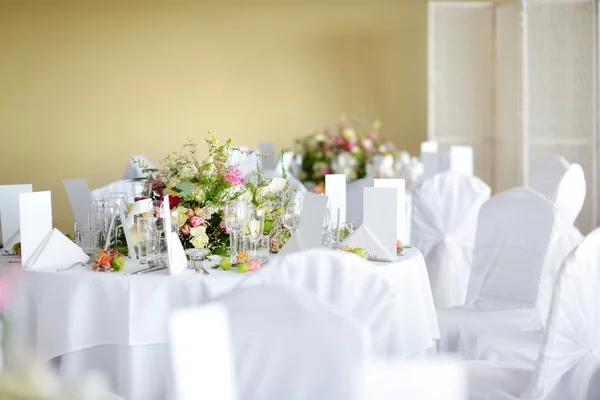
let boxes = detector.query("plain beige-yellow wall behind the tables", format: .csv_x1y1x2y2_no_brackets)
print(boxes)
0,0,427,231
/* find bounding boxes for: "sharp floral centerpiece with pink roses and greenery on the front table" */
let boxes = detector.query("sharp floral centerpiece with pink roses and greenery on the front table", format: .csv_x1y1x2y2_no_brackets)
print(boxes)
138,132,292,256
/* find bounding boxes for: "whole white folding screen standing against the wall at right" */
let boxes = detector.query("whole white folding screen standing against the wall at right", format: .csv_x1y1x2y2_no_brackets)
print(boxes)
429,0,599,232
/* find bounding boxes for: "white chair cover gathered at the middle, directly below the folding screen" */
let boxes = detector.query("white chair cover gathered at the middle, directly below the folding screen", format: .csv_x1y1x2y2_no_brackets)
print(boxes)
411,172,490,308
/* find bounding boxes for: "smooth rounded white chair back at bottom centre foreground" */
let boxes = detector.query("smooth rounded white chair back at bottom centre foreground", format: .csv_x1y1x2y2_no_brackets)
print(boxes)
216,285,368,400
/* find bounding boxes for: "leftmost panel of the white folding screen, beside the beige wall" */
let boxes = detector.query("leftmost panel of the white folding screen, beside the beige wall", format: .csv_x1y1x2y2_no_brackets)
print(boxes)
428,2,494,182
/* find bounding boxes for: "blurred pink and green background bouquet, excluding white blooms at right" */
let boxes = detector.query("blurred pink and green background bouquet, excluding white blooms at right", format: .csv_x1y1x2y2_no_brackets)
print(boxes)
295,117,394,192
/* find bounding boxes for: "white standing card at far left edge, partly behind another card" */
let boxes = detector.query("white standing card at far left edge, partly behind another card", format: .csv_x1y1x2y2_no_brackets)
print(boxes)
0,185,33,249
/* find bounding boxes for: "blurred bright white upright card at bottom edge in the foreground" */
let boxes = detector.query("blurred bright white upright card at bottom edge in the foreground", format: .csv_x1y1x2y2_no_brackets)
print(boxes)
169,304,238,400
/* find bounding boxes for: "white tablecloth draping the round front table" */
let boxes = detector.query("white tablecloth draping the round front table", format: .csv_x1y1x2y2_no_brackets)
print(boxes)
0,248,439,400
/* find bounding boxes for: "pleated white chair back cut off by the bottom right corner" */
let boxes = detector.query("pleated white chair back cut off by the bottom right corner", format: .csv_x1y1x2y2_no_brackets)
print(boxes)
523,229,600,400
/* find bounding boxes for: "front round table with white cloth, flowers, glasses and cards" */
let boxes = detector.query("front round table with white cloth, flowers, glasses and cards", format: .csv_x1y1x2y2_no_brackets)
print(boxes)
0,133,439,399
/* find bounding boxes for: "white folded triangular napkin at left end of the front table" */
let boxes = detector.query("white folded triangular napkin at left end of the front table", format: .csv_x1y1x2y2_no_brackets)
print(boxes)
23,228,89,268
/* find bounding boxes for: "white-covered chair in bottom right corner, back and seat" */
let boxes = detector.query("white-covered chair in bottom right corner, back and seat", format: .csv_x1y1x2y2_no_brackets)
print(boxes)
470,230,600,400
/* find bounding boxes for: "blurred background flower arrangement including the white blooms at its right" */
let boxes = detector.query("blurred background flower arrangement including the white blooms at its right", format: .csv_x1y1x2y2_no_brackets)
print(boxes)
293,117,423,193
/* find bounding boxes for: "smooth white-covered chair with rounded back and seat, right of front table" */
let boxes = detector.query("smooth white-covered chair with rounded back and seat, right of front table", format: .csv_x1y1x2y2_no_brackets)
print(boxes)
438,188,556,351
